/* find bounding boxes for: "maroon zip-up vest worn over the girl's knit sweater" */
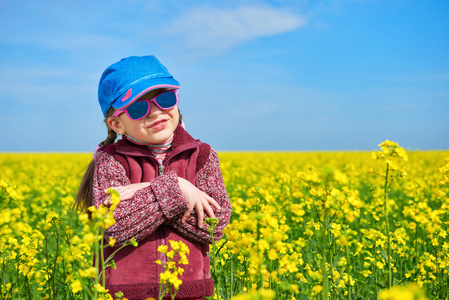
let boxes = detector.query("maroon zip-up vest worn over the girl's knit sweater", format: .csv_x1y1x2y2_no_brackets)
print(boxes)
101,126,214,299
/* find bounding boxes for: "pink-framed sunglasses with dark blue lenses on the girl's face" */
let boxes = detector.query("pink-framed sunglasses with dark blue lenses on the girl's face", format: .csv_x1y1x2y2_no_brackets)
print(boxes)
112,89,178,120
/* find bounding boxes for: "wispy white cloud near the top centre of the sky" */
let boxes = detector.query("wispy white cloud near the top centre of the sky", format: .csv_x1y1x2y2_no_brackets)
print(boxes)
162,6,307,52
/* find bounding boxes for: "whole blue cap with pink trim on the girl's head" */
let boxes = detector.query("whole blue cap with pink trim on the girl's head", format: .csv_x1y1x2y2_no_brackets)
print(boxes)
98,56,179,117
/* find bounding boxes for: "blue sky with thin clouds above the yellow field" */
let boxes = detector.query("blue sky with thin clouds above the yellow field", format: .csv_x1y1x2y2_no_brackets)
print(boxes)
0,0,449,152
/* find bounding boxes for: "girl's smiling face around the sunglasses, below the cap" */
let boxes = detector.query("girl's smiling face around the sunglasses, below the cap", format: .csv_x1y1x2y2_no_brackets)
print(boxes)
108,89,179,144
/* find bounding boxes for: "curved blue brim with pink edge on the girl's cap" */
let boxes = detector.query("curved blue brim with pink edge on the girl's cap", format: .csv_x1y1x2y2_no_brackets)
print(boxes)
112,78,180,109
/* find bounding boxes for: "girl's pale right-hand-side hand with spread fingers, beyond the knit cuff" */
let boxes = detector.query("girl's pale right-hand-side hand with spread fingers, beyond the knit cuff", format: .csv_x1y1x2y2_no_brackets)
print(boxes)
178,177,221,228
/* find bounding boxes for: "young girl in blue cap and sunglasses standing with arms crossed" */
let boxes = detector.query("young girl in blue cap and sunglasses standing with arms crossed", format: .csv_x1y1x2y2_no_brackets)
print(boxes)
76,56,231,299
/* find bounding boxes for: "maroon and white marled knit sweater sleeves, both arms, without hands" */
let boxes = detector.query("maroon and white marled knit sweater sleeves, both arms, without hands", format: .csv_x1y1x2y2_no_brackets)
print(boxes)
93,150,231,244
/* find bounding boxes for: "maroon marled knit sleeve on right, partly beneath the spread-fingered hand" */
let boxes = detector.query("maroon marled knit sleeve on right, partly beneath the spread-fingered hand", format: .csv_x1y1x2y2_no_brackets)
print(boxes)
168,149,232,243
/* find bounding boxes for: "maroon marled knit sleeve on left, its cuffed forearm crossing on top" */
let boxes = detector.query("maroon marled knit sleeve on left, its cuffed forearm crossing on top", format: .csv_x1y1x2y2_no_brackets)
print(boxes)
92,152,188,245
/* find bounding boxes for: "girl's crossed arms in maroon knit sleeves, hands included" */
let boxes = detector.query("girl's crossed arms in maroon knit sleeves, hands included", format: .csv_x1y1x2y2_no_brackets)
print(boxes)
93,151,231,243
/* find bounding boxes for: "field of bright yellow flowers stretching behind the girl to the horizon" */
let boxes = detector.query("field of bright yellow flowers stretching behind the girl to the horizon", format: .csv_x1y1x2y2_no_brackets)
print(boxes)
0,141,449,300
